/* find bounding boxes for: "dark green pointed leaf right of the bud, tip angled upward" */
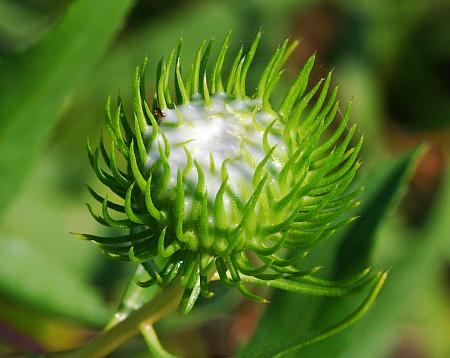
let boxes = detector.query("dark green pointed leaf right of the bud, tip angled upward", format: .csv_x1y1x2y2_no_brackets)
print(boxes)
239,147,423,356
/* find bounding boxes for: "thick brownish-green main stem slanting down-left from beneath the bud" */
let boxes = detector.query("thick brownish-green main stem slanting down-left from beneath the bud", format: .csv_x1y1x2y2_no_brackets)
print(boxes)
49,280,183,358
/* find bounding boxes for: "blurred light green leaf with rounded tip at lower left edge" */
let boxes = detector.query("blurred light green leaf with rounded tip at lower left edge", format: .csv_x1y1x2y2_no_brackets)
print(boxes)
0,236,110,326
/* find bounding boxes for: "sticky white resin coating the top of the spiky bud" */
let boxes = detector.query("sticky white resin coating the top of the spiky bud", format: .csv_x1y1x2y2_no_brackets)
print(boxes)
146,94,280,200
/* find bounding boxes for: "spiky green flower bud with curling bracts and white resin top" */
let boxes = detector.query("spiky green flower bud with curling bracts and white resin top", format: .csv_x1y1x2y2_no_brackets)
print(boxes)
81,33,375,311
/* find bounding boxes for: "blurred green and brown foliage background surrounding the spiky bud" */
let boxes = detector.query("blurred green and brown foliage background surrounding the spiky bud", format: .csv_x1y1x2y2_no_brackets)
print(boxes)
0,0,450,357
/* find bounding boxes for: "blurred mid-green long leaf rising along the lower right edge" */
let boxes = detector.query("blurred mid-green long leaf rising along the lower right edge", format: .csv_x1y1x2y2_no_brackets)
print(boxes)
302,166,450,358
